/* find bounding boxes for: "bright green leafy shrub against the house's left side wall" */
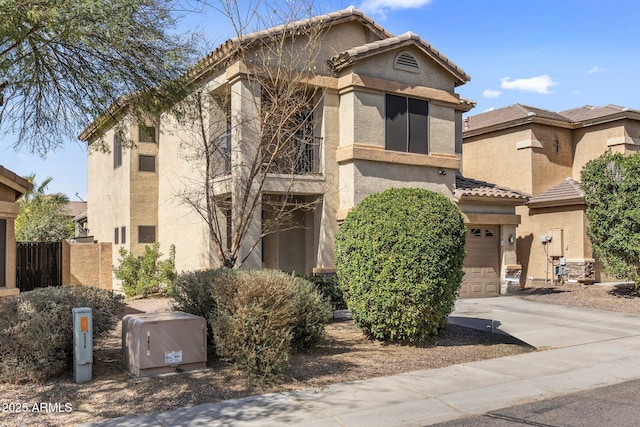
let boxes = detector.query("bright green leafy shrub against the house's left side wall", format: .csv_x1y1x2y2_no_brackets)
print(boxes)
113,242,177,297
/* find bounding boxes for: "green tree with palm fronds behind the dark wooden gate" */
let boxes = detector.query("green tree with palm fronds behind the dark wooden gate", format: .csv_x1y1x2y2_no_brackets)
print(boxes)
16,174,74,242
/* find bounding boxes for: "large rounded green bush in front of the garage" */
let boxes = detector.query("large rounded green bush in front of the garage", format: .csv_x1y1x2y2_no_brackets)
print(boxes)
336,188,465,341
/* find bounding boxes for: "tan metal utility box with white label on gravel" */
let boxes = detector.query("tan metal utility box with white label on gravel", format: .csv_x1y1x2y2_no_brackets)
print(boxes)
122,311,207,377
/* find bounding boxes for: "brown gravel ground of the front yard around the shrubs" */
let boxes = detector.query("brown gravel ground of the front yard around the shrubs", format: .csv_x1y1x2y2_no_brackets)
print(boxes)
0,285,640,427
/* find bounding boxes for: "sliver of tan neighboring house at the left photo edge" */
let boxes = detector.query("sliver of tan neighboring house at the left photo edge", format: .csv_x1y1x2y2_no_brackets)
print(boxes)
0,166,31,297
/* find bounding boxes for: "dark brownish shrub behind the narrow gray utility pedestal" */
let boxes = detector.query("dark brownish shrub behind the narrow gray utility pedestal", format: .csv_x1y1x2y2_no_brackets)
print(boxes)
0,286,124,383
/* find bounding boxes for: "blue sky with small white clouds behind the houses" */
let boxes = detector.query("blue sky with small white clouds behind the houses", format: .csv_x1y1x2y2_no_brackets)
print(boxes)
0,0,640,200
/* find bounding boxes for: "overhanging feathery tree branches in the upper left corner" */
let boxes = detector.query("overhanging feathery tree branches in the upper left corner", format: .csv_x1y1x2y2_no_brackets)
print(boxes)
0,0,193,154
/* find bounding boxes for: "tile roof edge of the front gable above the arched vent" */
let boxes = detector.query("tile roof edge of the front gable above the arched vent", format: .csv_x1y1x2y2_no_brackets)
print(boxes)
329,32,471,84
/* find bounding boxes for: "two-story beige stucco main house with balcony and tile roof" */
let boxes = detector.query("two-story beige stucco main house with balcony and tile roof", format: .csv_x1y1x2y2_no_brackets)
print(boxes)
80,8,526,296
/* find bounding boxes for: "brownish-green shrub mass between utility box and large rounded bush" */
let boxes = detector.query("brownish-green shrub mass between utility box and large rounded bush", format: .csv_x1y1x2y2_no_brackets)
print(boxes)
170,269,331,379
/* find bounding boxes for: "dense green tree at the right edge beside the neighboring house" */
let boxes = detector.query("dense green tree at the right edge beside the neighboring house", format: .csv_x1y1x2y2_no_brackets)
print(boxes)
581,151,640,291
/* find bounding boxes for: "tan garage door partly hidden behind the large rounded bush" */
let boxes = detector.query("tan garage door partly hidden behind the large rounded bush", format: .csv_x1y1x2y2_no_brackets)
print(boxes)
460,225,500,298
